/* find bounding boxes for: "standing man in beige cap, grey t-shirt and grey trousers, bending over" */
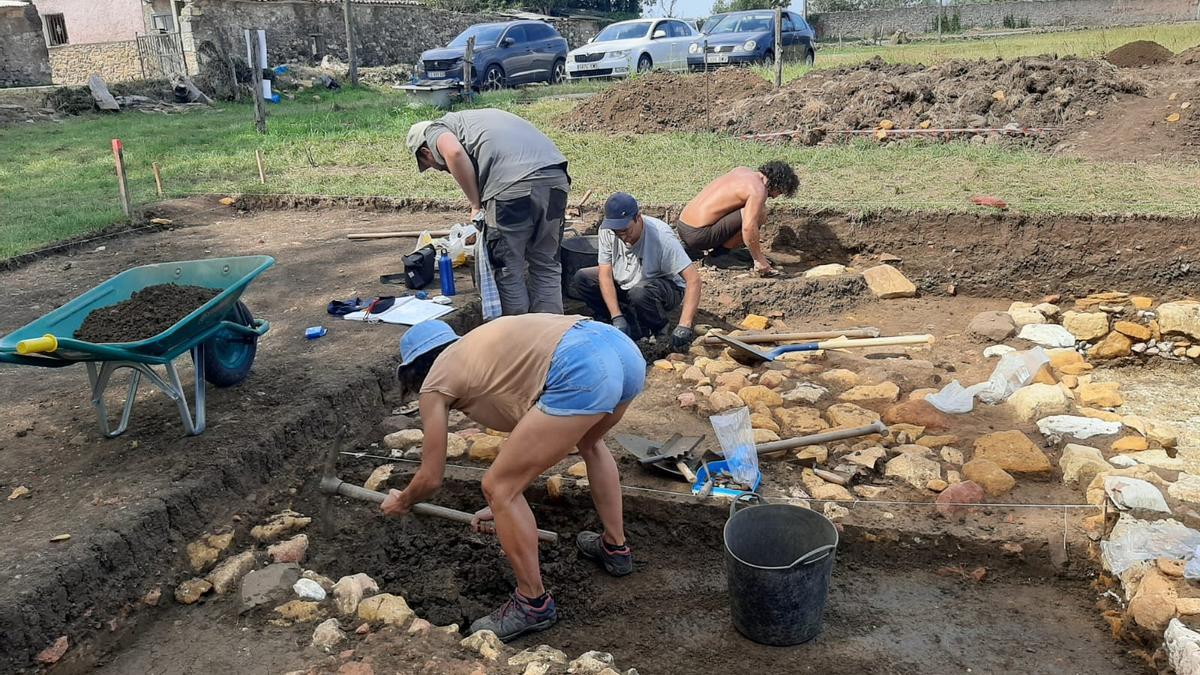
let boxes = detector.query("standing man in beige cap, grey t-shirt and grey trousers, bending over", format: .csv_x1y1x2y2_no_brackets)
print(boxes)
407,108,571,315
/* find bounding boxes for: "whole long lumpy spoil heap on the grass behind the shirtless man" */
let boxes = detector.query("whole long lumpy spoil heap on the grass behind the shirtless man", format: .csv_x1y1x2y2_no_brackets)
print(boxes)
563,56,1142,144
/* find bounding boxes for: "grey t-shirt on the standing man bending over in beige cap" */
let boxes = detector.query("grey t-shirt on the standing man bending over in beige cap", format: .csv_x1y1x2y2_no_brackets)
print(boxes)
425,108,566,202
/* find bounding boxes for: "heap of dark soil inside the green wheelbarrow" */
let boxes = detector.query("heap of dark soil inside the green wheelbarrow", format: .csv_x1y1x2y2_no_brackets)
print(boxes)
74,283,221,342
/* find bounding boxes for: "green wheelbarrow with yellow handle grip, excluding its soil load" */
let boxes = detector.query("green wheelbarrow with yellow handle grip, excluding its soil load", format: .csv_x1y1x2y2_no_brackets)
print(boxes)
0,256,275,438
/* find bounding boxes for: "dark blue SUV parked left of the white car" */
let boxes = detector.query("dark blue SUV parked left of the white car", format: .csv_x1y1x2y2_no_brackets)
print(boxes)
416,20,566,90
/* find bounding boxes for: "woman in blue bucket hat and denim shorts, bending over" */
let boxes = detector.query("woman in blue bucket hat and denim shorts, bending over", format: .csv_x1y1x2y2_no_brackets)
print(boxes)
380,313,646,640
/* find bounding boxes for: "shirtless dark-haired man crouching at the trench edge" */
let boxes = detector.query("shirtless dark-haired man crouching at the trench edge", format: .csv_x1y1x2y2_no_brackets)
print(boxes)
674,162,800,275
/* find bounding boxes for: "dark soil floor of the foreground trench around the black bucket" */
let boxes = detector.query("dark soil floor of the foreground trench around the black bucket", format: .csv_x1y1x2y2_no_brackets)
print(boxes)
295,473,1134,674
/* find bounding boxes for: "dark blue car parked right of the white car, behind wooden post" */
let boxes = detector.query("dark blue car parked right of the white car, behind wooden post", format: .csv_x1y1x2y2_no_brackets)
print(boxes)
688,10,816,71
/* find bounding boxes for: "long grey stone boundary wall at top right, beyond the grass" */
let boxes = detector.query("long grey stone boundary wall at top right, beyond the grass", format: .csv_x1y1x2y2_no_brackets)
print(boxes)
809,0,1200,40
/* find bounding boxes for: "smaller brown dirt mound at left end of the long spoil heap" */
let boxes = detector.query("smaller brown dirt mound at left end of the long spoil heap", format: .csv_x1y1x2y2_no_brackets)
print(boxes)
560,68,770,133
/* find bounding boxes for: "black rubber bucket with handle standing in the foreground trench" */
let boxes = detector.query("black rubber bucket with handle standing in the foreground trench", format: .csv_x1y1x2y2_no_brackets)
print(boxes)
725,494,838,645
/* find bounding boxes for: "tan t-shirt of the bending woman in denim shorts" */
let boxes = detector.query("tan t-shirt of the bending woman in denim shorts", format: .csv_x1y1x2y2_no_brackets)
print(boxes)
421,313,587,431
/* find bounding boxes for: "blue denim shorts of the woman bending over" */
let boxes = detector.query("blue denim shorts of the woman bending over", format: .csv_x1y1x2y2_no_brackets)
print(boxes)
538,321,646,417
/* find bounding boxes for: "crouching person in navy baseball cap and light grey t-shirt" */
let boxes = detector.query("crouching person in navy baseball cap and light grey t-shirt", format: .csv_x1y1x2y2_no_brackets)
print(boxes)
572,192,701,352
